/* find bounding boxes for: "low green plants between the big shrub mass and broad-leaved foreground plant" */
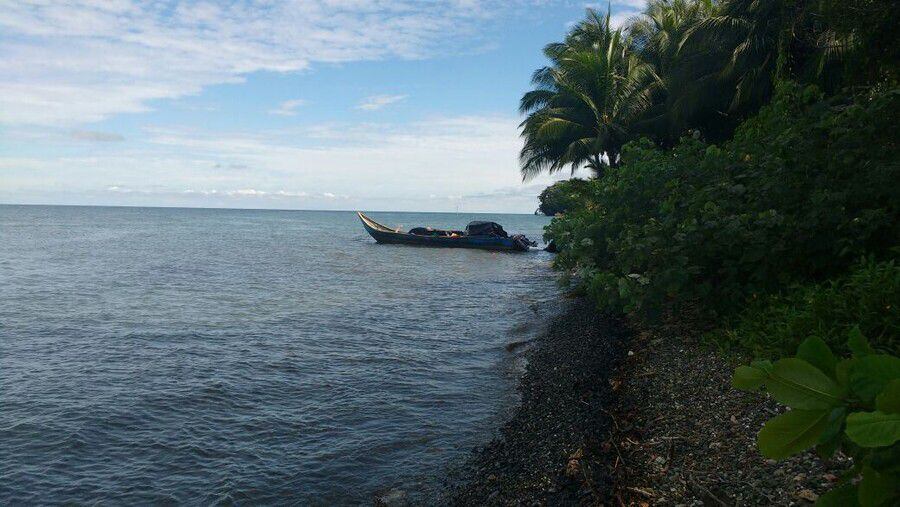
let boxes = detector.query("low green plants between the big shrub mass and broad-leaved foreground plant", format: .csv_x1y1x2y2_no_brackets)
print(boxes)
707,260,900,359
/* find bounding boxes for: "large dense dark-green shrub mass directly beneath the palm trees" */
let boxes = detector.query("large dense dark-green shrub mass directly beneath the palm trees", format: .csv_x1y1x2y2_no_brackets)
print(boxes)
546,83,900,318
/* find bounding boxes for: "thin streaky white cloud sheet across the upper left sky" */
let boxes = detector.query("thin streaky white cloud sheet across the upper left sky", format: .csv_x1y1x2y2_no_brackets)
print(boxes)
0,0,520,125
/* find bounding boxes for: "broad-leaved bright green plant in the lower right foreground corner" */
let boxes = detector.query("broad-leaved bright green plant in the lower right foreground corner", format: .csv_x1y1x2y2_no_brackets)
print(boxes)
733,334,900,506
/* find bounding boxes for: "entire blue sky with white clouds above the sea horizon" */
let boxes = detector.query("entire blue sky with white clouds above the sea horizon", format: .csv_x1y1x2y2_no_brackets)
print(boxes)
0,0,644,213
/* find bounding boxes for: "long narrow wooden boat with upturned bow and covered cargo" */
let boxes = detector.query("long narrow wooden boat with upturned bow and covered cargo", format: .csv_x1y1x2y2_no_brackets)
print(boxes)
356,211,532,252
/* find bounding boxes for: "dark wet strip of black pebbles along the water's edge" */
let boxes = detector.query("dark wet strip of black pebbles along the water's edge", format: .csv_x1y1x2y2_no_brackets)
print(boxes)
448,300,630,505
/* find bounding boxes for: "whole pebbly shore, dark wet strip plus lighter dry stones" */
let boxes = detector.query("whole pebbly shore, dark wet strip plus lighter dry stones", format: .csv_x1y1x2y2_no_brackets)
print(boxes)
446,299,849,506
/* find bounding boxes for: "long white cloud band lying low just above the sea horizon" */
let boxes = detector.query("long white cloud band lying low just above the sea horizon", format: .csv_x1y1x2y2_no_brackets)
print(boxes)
0,116,569,212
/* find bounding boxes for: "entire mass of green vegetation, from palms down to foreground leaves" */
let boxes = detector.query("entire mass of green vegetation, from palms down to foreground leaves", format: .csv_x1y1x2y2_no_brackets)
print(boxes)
521,0,900,505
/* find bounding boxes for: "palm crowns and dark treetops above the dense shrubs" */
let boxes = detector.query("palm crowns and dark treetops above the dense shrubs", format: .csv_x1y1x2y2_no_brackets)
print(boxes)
520,0,900,179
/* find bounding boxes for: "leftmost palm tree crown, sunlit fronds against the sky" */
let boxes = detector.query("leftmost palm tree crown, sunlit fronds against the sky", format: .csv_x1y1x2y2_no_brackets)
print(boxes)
519,9,655,180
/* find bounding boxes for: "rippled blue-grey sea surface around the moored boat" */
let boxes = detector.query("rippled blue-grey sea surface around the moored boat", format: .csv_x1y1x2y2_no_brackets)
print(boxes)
0,206,557,505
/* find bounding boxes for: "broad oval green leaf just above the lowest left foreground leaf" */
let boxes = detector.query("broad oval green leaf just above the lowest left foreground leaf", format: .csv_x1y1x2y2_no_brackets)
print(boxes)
766,358,842,410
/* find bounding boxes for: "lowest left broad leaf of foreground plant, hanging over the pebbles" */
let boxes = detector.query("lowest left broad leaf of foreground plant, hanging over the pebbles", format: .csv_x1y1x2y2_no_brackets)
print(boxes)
757,410,830,459
